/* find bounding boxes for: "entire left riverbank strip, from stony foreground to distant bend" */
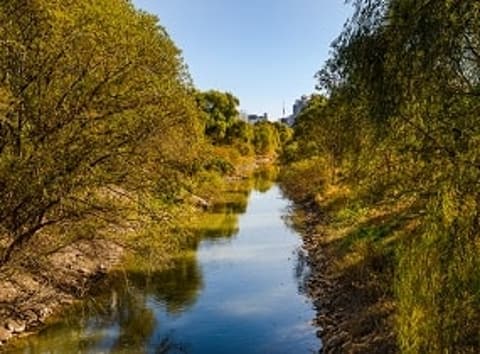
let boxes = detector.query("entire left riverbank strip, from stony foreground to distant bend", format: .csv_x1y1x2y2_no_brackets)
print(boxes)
0,157,272,348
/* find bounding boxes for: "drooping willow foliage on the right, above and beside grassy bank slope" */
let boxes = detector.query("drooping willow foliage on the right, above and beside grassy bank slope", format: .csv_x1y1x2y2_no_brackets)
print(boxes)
284,0,480,353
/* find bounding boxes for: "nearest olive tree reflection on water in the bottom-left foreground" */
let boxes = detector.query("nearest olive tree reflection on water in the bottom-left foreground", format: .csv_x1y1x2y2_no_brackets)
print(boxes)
14,287,187,354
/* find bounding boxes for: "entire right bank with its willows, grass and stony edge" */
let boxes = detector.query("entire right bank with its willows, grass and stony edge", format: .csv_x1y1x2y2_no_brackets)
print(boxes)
282,0,480,353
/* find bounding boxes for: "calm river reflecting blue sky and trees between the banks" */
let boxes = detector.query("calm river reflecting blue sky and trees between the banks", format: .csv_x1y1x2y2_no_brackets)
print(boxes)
9,185,321,354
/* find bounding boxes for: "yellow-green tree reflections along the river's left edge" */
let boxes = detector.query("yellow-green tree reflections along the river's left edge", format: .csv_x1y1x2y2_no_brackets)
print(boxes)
11,174,248,354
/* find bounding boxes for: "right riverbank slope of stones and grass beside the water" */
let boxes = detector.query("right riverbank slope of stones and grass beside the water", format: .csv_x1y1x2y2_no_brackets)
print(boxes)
284,192,398,353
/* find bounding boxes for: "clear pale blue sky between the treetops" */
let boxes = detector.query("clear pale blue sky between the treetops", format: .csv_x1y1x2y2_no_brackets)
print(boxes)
133,0,352,120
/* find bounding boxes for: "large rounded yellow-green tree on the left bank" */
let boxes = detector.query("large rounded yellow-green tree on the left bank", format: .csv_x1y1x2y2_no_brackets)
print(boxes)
0,0,199,263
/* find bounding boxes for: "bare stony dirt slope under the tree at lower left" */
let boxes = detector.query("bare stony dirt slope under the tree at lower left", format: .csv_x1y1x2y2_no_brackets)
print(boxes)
0,239,124,350
